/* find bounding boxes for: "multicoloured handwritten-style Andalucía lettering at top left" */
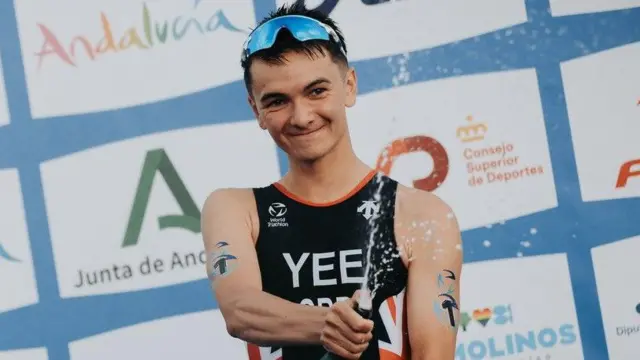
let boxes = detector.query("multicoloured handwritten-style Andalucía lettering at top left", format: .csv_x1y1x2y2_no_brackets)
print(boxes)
35,2,245,68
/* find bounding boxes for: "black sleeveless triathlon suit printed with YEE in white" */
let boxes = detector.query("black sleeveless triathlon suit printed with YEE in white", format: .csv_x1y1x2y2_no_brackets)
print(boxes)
248,172,410,360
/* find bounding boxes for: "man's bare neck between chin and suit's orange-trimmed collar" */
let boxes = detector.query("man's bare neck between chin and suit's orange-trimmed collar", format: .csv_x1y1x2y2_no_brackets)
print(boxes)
280,141,372,203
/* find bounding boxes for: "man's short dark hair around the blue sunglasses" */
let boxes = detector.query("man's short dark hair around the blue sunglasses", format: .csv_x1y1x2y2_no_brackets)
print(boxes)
241,1,349,94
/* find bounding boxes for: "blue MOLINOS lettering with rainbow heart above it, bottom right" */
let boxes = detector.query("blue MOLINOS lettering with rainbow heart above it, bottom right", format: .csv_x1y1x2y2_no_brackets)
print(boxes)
456,305,577,360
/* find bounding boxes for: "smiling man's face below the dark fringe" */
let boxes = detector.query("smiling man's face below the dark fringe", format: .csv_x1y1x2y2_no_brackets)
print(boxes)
249,52,356,161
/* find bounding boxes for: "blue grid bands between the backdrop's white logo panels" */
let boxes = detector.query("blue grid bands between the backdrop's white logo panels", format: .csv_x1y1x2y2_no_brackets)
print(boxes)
0,0,640,360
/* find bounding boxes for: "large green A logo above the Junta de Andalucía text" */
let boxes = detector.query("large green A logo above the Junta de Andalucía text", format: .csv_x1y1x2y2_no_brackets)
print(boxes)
122,149,200,247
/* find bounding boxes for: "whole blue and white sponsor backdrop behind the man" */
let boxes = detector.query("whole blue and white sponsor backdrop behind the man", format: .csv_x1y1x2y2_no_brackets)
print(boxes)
0,0,640,360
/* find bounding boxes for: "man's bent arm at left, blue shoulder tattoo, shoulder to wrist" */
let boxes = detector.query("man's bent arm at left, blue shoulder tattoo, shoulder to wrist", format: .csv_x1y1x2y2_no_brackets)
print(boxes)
202,189,329,346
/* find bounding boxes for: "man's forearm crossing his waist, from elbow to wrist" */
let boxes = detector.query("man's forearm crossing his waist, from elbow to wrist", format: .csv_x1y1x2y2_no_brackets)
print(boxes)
227,290,329,346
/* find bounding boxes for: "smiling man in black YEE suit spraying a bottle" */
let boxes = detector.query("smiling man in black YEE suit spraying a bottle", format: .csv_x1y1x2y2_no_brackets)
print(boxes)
202,5,462,360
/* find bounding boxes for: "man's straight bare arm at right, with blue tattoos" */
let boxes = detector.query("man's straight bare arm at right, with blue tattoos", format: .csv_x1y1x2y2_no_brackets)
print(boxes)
397,189,462,360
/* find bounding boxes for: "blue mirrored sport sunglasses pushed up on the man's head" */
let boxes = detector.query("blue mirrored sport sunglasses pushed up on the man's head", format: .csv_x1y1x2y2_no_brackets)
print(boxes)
242,15,346,61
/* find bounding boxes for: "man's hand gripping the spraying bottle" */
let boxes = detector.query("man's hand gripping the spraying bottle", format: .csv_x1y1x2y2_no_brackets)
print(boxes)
320,290,373,359
